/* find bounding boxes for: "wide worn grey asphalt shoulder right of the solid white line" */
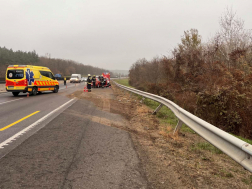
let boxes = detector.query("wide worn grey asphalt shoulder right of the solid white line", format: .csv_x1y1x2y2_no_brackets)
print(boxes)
0,90,148,189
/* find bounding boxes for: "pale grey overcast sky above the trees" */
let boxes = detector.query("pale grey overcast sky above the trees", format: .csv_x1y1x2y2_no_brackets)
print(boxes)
0,0,252,69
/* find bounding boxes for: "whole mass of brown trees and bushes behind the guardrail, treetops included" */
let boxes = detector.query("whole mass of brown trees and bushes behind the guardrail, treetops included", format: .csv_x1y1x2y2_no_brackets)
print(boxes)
129,10,252,139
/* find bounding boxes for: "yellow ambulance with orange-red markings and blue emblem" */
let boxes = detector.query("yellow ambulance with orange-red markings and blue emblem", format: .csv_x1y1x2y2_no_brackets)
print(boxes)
5,65,59,96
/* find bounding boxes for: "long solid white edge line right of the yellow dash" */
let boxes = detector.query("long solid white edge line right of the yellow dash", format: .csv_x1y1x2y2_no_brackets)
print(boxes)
0,98,75,149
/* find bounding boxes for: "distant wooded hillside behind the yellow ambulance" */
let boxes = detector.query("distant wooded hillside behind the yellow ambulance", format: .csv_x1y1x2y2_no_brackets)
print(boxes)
0,47,108,78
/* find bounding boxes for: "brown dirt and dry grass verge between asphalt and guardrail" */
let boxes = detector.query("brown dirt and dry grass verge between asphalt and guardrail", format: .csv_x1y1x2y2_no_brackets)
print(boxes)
69,86,252,188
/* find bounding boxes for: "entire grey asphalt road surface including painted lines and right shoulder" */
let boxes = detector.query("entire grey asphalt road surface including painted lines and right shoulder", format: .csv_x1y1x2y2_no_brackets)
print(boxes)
0,83,148,189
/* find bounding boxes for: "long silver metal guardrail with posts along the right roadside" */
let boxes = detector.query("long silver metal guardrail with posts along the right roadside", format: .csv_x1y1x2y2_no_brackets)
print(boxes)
114,81,252,172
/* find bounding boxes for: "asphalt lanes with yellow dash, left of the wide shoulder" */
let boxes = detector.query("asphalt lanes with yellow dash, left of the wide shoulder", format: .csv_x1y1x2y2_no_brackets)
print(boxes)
0,83,85,158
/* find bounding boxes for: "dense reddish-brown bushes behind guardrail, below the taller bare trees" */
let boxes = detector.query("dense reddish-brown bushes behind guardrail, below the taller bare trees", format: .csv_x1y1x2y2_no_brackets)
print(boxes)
129,54,252,138
